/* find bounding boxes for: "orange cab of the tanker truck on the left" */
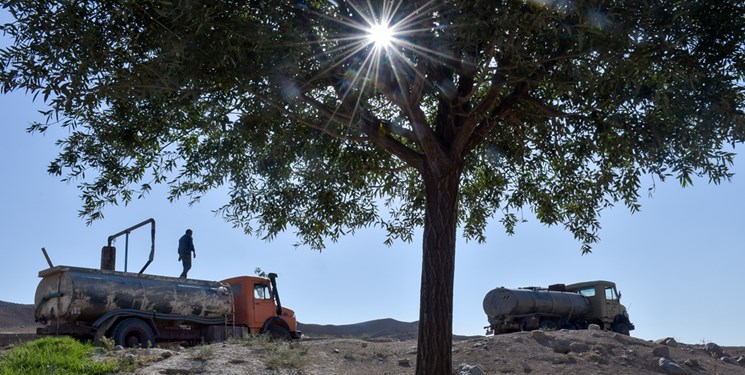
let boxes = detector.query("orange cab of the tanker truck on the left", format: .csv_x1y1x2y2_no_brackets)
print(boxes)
222,273,302,339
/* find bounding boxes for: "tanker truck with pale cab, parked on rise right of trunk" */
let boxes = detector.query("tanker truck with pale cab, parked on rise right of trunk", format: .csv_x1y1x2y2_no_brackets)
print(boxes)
483,280,634,335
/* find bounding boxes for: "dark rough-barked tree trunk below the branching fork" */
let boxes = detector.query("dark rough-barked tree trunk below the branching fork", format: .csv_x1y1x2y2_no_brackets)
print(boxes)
416,164,461,375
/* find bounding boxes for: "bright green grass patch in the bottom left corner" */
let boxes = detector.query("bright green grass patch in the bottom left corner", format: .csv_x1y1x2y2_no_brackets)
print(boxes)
0,337,133,375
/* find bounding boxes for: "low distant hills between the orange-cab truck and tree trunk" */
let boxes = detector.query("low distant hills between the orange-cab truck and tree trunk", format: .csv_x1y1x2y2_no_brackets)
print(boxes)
298,319,419,340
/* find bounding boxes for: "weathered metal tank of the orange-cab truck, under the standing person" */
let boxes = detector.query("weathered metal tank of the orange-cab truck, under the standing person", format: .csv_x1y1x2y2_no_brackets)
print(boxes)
34,266,233,323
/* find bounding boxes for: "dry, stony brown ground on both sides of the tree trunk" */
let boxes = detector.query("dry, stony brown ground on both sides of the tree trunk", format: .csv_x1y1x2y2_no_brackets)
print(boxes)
109,330,745,375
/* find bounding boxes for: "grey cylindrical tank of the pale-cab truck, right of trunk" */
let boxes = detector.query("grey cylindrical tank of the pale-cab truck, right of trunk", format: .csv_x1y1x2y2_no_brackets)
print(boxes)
483,287,590,318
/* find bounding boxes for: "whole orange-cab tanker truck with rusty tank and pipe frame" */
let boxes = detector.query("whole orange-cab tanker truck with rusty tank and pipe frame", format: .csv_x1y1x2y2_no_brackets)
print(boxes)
34,219,301,347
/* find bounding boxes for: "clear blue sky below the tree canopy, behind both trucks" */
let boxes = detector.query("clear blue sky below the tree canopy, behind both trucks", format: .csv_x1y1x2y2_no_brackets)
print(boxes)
0,13,745,346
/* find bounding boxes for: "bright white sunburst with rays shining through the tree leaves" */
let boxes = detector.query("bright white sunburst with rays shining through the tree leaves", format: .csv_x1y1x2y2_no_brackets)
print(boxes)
286,0,454,132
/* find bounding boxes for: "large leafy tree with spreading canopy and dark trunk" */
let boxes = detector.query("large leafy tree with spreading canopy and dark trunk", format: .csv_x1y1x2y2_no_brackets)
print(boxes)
0,0,745,374
